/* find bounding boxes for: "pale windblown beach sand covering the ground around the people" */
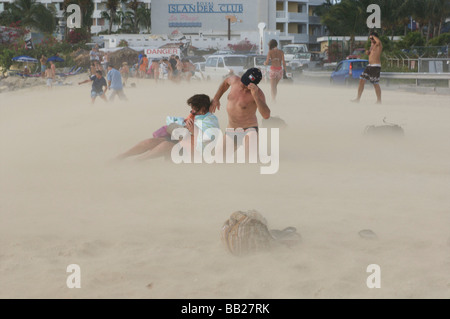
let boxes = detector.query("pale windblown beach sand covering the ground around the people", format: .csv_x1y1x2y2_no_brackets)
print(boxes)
0,75,450,299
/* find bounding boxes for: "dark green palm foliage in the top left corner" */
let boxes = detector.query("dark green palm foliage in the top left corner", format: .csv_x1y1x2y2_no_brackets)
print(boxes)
2,0,56,33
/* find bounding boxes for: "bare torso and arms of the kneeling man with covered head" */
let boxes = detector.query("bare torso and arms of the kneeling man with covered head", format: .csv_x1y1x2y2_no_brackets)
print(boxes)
211,72,270,129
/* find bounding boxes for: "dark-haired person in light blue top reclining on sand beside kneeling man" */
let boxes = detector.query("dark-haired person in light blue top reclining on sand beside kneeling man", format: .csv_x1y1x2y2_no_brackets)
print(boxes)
117,94,219,160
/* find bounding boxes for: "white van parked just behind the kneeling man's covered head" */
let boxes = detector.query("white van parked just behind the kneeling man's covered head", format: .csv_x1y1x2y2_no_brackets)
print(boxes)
203,54,247,80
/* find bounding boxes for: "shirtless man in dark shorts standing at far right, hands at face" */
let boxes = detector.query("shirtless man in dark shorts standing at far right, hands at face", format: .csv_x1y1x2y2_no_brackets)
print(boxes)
352,31,383,104
